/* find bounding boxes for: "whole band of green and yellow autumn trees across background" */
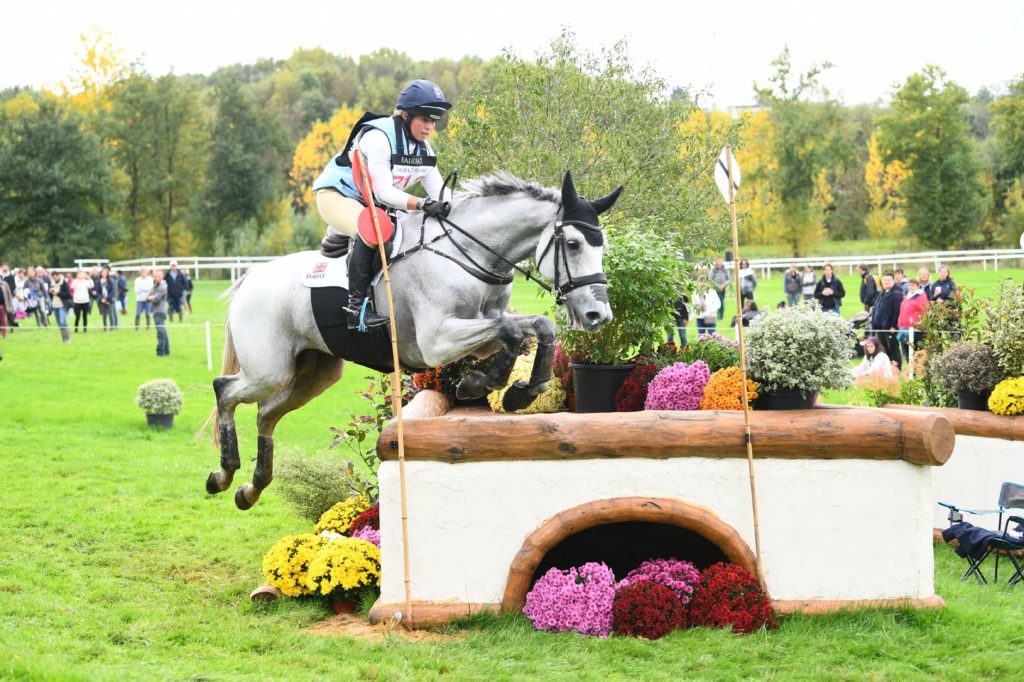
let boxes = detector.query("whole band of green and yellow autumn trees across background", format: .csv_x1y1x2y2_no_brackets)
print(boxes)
0,32,1024,265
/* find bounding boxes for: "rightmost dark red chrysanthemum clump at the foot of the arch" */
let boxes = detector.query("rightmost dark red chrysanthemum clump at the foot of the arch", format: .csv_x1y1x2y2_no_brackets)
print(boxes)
687,563,775,633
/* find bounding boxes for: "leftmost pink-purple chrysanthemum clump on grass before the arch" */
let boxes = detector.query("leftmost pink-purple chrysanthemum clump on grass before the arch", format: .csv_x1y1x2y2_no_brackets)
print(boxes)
522,562,617,637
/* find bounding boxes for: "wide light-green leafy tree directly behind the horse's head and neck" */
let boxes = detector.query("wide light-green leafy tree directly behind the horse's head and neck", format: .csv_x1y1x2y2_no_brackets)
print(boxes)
440,32,739,255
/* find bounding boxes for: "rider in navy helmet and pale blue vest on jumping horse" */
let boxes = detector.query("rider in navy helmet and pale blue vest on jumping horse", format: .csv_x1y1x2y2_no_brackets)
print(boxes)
313,79,452,329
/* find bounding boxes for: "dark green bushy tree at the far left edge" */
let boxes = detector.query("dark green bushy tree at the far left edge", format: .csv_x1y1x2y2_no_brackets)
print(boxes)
0,92,119,266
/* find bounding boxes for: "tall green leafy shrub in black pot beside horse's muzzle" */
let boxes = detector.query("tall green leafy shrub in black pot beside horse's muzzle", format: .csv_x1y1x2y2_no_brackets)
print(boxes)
558,224,688,412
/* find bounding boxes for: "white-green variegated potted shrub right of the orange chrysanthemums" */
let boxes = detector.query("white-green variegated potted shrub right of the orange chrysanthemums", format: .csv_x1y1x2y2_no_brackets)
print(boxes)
745,306,856,410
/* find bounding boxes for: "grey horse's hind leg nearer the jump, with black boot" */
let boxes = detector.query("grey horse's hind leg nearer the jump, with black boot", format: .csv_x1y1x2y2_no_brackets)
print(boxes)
234,350,344,510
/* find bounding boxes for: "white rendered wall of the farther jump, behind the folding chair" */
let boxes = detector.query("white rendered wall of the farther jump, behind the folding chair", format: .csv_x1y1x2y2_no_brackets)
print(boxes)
932,434,1024,530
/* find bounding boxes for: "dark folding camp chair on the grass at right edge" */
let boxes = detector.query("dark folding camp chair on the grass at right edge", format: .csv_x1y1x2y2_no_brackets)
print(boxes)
939,481,1024,585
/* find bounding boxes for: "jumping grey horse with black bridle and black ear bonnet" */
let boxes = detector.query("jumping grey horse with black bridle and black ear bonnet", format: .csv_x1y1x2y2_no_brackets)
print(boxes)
206,173,622,509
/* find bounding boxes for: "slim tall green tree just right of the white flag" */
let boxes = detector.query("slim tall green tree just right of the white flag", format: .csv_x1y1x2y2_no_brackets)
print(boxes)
754,47,839,256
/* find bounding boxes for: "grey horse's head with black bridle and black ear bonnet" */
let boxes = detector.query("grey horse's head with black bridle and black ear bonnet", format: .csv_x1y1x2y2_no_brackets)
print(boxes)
537,172,623,332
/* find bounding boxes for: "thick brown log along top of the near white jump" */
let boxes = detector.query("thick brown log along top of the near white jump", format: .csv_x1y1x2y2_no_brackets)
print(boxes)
377,396,954,466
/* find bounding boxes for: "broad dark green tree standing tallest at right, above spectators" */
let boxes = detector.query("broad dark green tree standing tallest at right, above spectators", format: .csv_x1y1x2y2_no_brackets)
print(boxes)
879,66,987,250
